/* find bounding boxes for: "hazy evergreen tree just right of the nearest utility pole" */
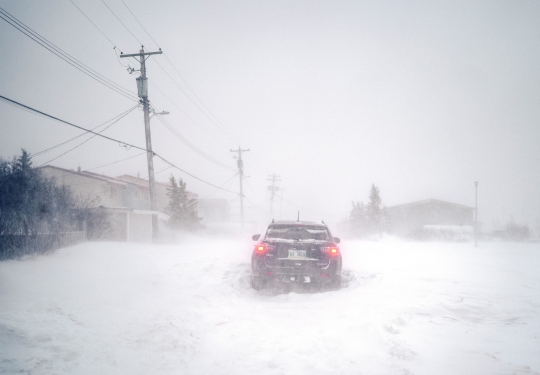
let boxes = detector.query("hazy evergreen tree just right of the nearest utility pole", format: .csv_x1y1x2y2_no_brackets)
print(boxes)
167,175,201,231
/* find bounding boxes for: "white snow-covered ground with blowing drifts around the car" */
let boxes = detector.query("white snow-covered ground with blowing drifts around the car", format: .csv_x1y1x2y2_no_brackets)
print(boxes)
0,239,540,375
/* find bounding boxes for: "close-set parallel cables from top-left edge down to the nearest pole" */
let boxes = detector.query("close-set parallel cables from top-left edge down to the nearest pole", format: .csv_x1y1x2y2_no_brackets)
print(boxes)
0,7,138,101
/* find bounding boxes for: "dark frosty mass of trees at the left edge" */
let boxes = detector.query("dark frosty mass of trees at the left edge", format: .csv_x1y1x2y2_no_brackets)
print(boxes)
0,150,108,260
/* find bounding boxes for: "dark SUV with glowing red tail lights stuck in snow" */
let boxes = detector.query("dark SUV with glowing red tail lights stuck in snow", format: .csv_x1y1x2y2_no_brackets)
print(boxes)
251,221,341,290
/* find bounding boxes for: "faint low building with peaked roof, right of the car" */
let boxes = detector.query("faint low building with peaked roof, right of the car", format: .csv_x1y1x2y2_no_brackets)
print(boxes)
386,199,474,236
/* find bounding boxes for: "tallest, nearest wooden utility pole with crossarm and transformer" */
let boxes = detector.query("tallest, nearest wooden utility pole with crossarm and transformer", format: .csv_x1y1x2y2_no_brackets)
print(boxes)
120,46,163,238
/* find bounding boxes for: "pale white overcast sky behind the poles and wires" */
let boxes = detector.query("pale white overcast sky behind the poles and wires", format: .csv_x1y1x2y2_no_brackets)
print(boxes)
0,0,540,232
